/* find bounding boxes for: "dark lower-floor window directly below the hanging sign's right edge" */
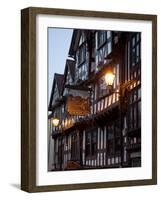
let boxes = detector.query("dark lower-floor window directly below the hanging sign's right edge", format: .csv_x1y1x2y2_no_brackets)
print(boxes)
86,130,97,157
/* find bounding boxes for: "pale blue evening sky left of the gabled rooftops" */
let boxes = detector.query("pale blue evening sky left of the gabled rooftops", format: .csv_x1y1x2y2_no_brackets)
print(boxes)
48,28,73,100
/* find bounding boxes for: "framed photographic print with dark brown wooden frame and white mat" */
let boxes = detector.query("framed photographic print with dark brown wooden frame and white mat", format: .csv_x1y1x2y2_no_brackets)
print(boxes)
21,7,157,192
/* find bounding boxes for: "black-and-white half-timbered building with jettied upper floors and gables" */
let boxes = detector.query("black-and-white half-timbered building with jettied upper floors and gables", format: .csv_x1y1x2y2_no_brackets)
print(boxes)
49,30,141,170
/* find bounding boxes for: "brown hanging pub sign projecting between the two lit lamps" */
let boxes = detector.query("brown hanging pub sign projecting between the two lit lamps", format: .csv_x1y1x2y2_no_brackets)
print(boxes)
67,96,90,116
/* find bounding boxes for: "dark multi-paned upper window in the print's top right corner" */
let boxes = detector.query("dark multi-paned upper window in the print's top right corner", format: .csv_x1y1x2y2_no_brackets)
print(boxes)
130,33,141,67
